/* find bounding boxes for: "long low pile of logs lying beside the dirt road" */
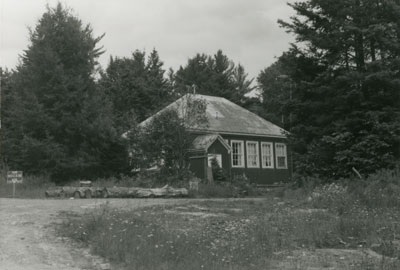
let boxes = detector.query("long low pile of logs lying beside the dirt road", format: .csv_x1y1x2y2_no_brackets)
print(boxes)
45,185,188,199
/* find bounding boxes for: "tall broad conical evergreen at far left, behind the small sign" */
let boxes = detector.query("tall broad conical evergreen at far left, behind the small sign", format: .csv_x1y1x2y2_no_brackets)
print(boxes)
2,4,124,181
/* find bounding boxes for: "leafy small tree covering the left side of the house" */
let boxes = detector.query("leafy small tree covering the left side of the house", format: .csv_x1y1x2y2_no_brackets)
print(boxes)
127,94,208,179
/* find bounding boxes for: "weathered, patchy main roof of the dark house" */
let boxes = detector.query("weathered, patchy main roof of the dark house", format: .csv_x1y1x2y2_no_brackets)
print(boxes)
140,94,287,137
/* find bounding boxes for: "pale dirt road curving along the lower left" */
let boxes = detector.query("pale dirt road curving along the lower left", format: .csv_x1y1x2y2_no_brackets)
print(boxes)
0,198,182,270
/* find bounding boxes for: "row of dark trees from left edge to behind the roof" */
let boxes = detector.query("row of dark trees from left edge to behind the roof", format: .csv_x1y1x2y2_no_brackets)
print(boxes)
1,3,255,181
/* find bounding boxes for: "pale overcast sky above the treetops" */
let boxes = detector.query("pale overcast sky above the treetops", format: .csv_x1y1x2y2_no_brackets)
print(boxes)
0,0,293,77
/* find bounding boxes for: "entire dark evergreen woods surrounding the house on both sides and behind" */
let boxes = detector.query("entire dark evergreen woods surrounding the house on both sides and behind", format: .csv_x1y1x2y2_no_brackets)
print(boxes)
0,0,400,181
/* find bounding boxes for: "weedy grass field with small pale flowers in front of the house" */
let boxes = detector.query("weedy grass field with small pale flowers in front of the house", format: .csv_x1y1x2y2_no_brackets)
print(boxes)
59,174,400,270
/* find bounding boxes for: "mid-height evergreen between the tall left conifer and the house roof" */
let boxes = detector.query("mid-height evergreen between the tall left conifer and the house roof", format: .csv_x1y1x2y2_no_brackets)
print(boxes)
100,50,171,126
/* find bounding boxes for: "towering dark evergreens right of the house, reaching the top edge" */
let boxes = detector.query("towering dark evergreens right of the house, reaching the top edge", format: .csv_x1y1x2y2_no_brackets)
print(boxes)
280,0,400,177
